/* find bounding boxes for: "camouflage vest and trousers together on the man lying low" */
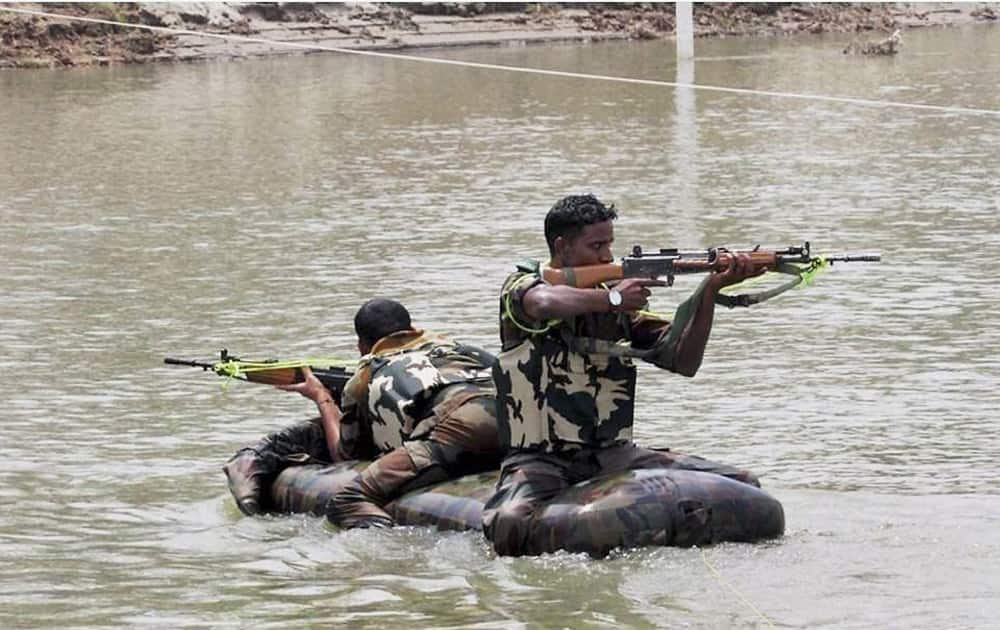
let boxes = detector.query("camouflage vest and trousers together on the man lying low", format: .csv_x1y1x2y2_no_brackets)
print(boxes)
327,331,501,527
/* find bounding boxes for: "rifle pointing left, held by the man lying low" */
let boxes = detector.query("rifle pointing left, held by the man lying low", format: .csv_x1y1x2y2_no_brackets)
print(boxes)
163,349,353,405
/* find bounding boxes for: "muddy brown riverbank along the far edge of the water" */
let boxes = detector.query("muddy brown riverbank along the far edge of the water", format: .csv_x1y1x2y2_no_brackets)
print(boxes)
0,2,1000,68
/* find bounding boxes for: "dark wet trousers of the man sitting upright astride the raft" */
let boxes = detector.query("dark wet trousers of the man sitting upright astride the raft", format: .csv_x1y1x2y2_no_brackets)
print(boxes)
483,443,760,556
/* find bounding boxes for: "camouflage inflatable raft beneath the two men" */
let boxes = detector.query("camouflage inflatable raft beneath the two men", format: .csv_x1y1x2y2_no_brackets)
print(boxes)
269,454,784,557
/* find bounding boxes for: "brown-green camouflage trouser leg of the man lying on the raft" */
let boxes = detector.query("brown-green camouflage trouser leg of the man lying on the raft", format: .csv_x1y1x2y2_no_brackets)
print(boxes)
327,396,502,528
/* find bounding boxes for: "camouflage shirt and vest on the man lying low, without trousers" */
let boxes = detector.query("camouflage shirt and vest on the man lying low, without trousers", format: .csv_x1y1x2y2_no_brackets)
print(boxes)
341,330,496,458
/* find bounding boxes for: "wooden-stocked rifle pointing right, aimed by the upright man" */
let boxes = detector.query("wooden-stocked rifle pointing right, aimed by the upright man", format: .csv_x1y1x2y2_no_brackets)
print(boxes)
542,241,882,308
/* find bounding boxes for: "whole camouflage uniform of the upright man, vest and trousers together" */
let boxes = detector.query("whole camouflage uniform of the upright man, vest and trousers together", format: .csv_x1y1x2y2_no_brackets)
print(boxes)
483,263,758,555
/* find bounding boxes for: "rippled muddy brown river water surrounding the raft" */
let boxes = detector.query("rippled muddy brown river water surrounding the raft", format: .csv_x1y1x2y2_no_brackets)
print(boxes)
0,27,1000,628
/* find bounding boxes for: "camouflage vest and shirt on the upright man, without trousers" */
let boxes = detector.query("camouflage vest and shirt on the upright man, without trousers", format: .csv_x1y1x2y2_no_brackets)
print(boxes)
493,263,669,452
